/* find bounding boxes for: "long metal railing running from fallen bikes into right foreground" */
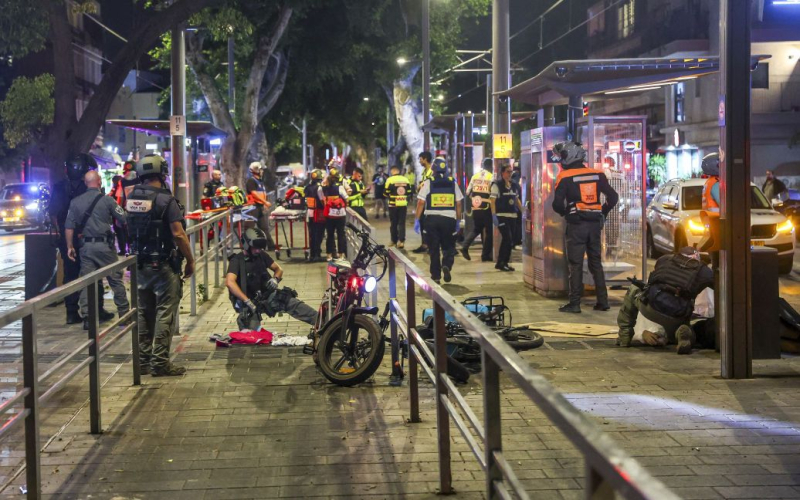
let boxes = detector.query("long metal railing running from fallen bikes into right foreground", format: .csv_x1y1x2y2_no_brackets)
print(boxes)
389,249,680,500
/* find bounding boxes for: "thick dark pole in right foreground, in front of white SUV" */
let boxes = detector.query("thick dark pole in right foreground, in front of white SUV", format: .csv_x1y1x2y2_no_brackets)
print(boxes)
717,0,753,378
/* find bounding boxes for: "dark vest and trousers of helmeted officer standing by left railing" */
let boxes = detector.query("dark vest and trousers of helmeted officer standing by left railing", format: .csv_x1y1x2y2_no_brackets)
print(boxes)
126,185,184,372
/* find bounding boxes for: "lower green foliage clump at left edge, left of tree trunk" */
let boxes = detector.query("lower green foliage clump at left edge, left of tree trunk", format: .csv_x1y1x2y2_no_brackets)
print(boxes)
0,73,55,148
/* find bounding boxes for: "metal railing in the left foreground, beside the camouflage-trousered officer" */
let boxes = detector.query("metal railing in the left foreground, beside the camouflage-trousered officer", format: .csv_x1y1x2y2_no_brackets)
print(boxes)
0,257,141,499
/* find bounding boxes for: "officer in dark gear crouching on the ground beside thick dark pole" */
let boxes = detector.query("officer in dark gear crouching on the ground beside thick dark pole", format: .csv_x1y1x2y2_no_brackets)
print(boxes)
617,247,715,354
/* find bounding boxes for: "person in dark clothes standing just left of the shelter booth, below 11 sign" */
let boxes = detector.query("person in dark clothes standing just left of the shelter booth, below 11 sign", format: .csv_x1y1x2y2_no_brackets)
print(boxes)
490,165,522,271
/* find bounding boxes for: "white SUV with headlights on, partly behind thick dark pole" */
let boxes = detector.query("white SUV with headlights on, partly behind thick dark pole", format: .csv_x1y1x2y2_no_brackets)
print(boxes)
647,179,795,274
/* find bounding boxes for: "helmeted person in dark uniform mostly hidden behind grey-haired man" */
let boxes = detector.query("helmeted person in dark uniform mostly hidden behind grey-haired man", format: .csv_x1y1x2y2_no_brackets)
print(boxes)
50,154,114,325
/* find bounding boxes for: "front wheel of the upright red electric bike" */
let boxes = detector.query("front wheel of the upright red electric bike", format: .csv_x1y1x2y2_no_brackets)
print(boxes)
317,315,386,387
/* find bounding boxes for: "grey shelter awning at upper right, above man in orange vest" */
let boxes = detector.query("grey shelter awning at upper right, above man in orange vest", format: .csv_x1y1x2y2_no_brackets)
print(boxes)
498,55,770,106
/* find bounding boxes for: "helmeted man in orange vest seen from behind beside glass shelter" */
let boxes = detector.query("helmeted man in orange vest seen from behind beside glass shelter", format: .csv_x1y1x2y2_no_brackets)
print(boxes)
553,141,619,313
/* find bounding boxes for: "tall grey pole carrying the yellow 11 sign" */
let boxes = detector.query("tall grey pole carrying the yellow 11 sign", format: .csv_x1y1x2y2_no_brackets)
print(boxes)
492,0,511,166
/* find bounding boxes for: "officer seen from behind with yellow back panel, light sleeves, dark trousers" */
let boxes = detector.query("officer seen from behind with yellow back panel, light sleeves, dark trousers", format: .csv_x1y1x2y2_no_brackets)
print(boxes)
414,158,464,283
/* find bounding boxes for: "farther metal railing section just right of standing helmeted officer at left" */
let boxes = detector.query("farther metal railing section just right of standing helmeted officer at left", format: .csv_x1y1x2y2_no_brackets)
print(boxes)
186,210,235,316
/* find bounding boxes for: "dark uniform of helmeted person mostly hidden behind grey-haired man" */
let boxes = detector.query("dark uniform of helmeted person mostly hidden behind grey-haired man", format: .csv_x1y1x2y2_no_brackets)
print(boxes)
50,179,103,319
